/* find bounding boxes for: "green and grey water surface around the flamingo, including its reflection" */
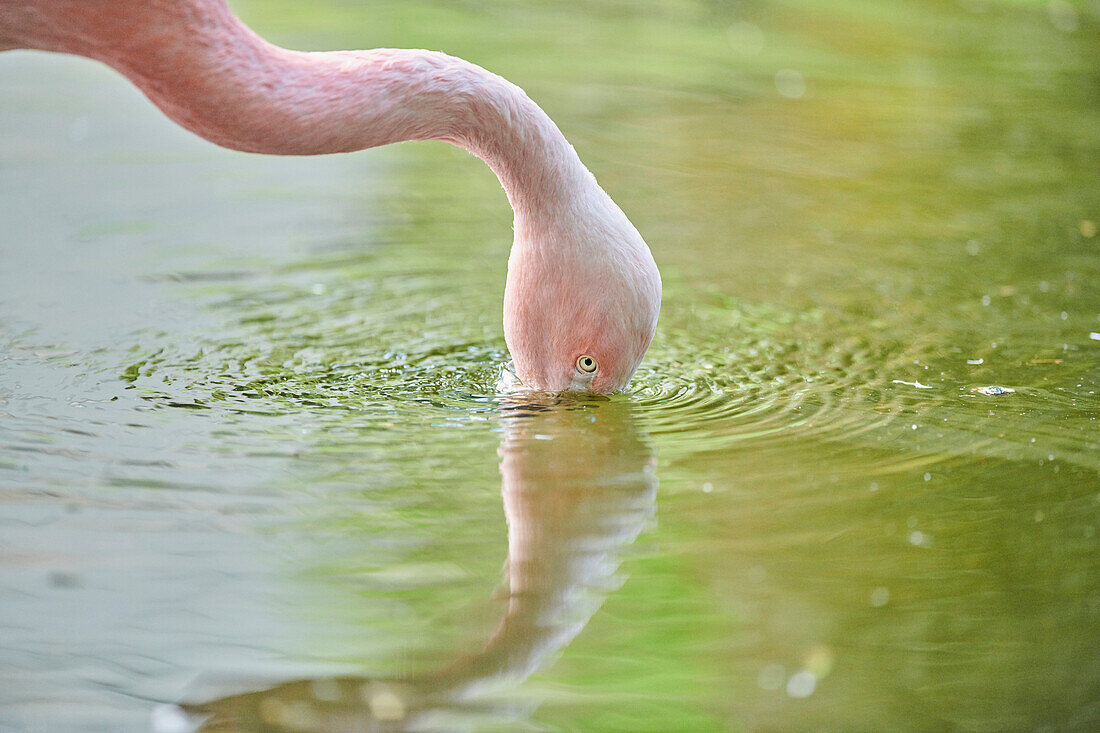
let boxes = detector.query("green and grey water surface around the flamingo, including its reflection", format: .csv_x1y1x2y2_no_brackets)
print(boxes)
0,0,1100,731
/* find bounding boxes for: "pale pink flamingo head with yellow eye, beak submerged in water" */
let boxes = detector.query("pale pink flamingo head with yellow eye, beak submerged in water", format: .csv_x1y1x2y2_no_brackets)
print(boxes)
504,189,661,394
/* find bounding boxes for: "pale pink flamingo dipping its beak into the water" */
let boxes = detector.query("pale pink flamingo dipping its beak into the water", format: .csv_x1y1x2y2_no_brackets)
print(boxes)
0,0,661,393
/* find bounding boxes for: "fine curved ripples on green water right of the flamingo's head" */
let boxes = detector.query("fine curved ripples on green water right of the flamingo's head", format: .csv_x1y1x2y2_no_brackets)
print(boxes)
630,305,1100,470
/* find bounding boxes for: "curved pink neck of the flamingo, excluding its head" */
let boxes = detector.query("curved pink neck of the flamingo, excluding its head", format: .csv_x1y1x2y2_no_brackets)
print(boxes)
0,0,592,223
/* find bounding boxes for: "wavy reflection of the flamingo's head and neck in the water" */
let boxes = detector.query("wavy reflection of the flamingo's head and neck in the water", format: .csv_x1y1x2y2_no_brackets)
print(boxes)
169,397,657,732
